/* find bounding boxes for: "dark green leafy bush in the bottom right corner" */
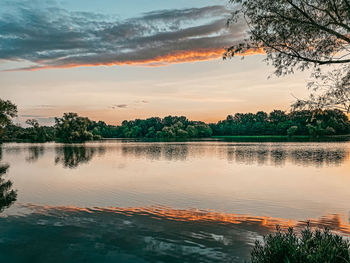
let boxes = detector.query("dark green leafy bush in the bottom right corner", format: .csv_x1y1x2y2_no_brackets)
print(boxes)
251,225,350,263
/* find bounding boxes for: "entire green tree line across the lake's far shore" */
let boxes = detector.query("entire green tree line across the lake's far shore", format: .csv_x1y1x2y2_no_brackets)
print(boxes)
0,99,350,143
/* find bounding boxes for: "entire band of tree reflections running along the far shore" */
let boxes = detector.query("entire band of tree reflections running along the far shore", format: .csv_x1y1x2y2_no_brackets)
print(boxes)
5,141,350,168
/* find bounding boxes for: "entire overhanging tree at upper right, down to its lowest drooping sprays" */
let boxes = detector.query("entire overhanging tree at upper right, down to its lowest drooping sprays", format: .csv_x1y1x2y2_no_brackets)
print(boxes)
224,0,350,113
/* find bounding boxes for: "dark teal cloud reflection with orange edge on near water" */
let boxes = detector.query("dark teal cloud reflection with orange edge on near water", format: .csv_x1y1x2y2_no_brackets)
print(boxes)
0,205,350,262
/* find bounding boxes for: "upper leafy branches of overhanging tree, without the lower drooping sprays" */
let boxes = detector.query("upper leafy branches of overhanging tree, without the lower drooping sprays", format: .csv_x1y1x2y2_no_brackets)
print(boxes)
225,0,350,75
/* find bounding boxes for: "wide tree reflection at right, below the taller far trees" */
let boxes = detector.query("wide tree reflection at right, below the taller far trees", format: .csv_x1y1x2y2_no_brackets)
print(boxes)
227,146,349,167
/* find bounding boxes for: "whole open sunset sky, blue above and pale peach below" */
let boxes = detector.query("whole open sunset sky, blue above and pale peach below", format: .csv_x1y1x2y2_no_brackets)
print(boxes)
0,0,308,125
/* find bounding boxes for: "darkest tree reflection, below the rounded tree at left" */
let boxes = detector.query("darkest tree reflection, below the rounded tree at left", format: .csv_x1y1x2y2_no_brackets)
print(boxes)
55,145,106,168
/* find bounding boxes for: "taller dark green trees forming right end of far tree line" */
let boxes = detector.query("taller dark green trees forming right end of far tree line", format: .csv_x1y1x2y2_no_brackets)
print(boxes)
210,110,350,137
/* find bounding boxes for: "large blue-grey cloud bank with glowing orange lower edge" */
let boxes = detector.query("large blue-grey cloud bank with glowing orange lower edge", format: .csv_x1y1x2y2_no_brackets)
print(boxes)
0,1,252,70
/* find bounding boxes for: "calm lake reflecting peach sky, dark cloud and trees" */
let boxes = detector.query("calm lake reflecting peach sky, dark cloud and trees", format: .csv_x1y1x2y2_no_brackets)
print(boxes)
0,140,350,262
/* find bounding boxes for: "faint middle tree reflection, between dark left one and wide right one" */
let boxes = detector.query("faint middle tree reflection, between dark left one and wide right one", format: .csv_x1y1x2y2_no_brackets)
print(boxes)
122,144,188,161
